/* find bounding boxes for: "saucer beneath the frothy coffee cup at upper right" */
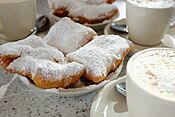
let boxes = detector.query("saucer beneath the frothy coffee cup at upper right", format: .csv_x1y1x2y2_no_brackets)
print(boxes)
104,19,175,52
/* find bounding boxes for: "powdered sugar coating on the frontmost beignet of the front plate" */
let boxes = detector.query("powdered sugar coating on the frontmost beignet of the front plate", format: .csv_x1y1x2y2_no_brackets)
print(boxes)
7,56,84,81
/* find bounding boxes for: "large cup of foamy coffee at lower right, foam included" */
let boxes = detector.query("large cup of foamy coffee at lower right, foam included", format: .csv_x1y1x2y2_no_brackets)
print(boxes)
126,48,175,117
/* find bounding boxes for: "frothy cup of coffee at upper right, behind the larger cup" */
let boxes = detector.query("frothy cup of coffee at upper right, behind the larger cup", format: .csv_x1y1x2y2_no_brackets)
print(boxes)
126,0,175,46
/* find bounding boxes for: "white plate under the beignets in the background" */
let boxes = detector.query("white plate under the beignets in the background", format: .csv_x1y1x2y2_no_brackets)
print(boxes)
50,0,126,30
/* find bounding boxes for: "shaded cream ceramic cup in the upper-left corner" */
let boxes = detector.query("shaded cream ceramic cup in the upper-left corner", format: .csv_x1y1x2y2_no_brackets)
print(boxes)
0,0,36,41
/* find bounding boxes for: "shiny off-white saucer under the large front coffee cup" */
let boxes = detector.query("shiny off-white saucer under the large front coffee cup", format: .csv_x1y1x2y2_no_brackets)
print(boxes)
90,75,128,117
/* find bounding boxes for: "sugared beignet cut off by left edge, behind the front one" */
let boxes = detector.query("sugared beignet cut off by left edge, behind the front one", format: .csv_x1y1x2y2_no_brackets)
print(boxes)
0,35,51,68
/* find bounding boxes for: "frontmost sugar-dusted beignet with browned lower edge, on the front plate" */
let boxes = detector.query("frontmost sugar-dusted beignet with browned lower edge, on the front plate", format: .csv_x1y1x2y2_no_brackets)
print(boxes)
7,56,84,89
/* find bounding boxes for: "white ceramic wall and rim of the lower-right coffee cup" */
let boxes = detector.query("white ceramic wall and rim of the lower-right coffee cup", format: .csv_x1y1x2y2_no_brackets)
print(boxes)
126,48,175,117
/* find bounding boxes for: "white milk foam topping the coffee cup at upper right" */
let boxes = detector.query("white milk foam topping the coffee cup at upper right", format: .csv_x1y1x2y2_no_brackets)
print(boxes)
128,0,175,8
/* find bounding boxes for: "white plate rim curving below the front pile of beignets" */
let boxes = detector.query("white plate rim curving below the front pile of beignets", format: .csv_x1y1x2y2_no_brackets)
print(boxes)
18,64,123,97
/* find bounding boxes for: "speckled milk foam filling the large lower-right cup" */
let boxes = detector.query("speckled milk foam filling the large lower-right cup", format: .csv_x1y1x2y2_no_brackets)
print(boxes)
131,49,175,99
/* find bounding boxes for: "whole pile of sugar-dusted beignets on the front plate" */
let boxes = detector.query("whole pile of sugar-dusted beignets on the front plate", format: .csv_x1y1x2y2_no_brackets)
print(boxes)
0,18,132,89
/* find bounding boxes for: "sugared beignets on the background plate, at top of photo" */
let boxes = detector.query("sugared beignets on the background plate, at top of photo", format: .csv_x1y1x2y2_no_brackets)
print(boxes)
48,0,118,24
